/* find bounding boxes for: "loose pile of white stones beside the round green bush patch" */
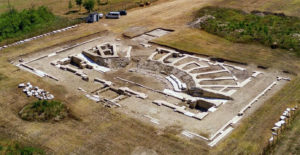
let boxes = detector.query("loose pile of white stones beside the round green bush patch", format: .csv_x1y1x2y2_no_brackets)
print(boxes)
18,82,54,100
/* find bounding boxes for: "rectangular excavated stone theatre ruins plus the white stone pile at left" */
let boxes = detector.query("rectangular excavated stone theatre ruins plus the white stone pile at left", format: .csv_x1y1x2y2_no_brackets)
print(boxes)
14,28,289,147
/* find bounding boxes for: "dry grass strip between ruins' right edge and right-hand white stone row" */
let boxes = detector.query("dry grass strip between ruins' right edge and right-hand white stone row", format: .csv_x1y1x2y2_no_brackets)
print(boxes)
213,77,300,154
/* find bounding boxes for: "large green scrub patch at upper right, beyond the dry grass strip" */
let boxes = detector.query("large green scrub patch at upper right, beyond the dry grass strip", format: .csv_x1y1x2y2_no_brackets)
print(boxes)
196,7,300,55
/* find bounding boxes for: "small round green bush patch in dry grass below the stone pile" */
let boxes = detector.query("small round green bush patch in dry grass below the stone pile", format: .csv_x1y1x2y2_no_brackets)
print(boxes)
19,100,69,121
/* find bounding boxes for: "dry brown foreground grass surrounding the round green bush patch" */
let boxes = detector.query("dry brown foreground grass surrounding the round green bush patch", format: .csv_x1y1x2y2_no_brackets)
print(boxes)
0,76,206,154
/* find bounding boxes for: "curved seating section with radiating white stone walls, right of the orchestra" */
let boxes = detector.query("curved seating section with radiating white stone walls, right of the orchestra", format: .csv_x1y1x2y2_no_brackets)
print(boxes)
148,48,251,96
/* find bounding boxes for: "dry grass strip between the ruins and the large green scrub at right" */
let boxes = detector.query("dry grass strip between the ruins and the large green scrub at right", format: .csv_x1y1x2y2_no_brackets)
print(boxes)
154,28,300,73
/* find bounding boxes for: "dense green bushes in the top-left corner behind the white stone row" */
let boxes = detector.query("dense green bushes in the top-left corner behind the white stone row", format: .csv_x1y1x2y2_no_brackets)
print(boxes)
0,6,80,44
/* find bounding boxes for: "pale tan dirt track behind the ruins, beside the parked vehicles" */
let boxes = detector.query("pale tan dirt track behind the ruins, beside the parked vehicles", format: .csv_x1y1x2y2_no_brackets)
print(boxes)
87,0,212,33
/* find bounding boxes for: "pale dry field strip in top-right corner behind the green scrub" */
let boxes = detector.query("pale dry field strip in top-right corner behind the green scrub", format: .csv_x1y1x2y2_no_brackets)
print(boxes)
213,0,300,17
